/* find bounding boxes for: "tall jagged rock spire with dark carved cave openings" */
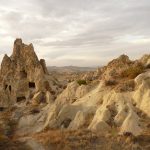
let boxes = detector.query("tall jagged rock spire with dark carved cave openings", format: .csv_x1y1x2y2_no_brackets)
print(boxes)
0,39,48,103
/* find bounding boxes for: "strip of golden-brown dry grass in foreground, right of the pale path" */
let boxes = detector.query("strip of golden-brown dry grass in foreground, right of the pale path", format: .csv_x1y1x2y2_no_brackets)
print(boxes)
33,128,147,150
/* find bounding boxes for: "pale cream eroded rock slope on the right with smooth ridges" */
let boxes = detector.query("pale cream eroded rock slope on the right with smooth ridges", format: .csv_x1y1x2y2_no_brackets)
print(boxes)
42,55,150,136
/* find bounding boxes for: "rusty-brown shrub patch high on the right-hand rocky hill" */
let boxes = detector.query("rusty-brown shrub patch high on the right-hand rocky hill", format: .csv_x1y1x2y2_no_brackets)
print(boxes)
121,64,144,79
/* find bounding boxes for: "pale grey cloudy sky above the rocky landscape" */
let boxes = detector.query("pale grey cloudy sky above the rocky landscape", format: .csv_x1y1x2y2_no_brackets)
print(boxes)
0,0,150,66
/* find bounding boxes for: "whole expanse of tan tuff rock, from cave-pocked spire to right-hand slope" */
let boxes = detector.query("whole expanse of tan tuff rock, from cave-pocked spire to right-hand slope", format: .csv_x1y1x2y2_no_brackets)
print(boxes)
0,39,150,150
